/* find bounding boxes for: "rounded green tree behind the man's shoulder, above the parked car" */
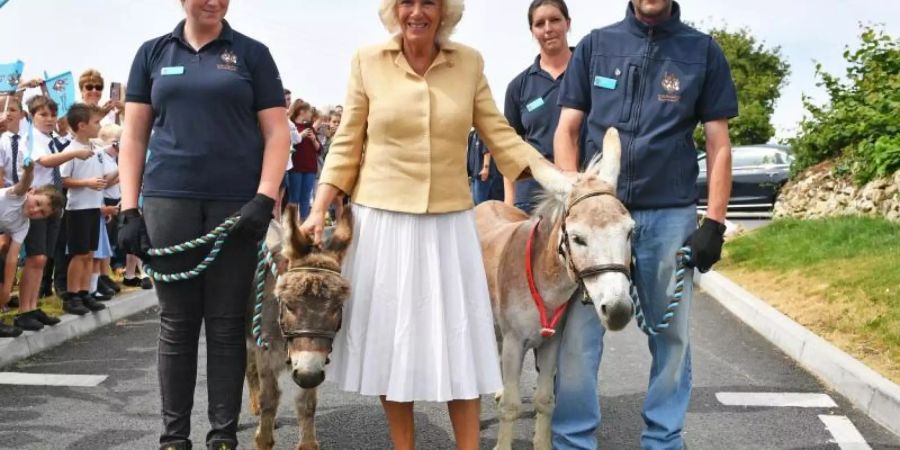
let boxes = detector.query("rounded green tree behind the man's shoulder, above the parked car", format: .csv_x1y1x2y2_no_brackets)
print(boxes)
694,26,790,150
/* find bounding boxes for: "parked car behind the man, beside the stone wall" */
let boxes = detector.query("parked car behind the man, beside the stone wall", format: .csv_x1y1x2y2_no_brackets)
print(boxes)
697,144,794,211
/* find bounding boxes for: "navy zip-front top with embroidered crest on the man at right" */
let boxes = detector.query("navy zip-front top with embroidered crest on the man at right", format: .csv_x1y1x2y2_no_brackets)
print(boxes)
559,2,738,209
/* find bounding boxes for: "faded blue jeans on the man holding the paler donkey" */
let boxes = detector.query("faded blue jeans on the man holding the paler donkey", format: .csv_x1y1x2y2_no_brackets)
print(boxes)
552,206,697,450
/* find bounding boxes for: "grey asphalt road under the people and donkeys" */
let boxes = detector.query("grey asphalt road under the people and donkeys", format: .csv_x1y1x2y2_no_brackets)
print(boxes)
0,295,900,450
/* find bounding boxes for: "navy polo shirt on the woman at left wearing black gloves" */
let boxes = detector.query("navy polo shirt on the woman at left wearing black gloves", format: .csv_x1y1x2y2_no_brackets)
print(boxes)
125,21,284,201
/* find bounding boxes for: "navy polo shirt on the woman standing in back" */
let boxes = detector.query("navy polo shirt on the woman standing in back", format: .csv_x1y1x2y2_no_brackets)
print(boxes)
503,51,588,212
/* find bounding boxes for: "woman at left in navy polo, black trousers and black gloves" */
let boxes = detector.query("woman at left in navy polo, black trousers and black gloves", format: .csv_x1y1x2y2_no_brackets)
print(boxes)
119,0,290,450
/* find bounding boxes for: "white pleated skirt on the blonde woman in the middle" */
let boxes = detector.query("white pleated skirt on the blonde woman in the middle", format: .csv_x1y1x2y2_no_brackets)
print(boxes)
326,204,502,402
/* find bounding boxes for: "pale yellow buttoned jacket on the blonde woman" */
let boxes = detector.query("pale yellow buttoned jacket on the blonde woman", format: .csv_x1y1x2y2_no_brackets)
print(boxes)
319,35,541,214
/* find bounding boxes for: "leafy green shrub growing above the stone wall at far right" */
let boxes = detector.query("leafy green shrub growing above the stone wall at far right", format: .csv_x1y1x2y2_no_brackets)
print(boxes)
790,25,900,183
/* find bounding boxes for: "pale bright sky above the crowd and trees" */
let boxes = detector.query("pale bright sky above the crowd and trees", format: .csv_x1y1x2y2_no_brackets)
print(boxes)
0,0,900,139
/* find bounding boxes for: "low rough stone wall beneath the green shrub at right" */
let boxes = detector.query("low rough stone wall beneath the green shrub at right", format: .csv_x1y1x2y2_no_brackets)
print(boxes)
774,163,900,222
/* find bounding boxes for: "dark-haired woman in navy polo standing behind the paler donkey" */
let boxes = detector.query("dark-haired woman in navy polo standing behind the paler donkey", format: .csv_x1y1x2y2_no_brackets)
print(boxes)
503,0,572,213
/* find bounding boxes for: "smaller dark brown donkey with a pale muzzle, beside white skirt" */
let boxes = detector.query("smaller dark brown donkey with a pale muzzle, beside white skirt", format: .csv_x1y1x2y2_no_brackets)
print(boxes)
247,206,353,450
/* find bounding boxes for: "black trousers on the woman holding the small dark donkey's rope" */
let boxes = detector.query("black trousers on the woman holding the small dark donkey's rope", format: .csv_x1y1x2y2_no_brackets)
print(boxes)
144,197,258,444
